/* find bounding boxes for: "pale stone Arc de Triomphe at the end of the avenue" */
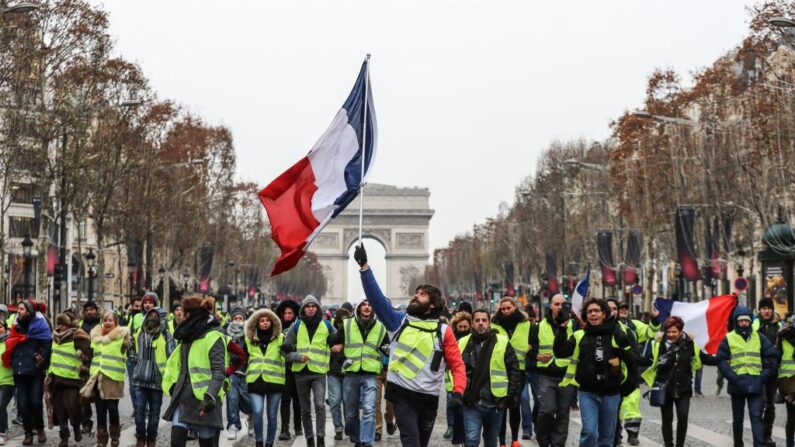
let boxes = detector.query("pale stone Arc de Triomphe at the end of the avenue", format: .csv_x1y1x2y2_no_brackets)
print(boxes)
309,183,433,305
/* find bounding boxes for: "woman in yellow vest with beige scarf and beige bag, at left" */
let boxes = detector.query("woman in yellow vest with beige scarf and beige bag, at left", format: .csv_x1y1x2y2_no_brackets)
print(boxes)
80,310,131,447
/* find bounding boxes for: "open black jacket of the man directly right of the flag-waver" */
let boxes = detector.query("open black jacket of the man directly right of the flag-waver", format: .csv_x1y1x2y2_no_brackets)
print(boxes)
461,330,524,408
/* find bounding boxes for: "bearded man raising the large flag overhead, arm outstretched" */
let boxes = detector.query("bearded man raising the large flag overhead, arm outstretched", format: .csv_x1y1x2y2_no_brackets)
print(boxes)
353,245,466,447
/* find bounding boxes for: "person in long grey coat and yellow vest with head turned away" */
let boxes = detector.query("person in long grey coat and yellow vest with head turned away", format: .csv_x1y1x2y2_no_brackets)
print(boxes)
163,295,228,447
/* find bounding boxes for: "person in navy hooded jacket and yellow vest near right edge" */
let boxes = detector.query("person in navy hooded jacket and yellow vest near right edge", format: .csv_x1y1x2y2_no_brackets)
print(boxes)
716,305,778,447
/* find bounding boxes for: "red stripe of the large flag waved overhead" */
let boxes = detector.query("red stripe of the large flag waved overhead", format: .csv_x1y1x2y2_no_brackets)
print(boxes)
259,157,320,276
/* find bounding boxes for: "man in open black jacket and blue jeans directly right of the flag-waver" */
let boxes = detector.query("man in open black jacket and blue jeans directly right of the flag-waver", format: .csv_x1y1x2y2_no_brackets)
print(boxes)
458,309,524,447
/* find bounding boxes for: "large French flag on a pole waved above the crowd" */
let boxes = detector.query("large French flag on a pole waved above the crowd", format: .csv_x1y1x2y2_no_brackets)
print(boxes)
259,57,377,275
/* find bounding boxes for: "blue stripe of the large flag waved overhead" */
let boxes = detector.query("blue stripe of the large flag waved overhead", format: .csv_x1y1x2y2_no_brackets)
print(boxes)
332,60,375,217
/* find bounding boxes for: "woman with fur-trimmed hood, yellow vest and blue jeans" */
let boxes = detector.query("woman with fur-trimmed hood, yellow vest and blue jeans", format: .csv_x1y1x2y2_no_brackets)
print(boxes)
245,309,286,447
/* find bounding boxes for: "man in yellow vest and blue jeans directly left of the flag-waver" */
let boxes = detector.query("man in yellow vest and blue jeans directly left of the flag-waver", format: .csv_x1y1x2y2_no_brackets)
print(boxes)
332,297,386,447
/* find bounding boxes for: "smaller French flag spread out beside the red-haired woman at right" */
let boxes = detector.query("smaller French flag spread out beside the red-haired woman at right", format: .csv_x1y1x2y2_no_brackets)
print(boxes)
654,294,737,355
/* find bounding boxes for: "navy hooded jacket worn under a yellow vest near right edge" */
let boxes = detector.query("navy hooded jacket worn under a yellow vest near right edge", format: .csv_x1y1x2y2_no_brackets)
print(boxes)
715,305,778,396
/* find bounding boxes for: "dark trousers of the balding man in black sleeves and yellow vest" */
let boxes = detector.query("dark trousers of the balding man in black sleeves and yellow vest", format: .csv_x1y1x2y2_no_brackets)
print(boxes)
535,375,574,447
